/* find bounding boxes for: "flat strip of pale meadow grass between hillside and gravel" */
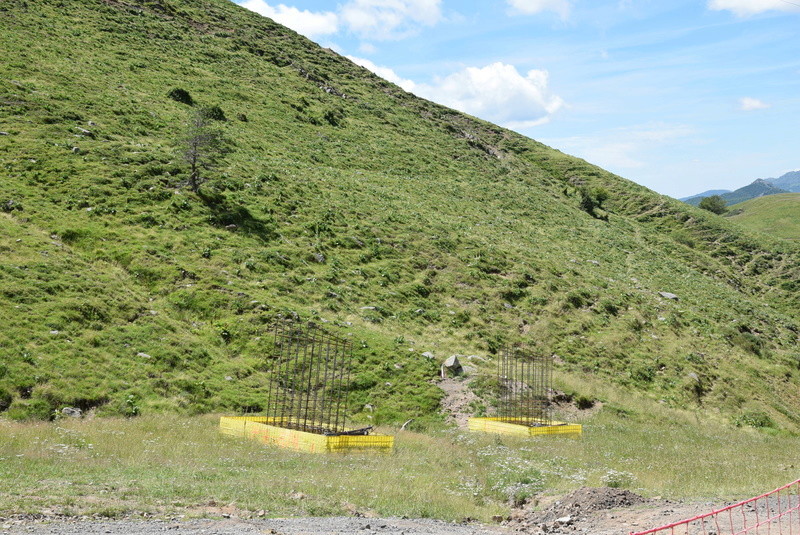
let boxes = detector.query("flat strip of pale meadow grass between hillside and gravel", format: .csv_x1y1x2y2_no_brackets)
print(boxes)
0,404,800,521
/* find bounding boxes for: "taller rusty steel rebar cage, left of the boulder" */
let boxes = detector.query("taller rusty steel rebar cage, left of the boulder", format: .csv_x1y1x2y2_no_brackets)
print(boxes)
266,322,354,435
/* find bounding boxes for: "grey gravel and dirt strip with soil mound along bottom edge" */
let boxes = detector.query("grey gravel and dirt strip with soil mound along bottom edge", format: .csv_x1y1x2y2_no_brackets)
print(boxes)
0,487,744,535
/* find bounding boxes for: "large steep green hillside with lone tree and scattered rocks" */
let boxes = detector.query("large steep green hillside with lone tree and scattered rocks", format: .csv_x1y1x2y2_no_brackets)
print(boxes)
0,0,800,429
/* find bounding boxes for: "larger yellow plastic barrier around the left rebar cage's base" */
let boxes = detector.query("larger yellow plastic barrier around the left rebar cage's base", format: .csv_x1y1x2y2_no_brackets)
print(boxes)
219,416,394,453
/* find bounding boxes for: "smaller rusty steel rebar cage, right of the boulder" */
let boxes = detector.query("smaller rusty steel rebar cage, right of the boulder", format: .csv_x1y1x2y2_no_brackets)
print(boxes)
497,346,553,426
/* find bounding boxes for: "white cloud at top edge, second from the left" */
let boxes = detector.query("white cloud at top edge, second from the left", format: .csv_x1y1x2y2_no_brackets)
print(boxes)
339,0,442,41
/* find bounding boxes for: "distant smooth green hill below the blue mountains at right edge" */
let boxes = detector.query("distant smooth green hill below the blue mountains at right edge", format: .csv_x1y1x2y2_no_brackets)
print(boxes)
727,193,800,240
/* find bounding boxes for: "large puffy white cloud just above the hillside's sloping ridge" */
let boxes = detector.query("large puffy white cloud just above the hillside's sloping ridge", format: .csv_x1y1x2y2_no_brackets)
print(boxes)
415,62,564,129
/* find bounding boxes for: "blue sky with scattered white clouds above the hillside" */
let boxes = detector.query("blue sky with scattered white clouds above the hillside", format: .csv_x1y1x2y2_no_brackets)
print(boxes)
231,0,800,197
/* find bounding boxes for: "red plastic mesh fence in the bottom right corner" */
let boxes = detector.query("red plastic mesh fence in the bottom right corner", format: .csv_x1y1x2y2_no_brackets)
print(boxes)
631,479,800,535
